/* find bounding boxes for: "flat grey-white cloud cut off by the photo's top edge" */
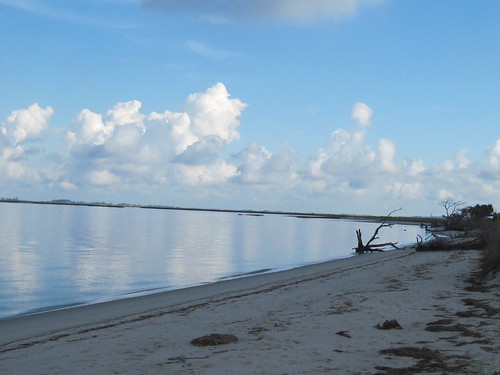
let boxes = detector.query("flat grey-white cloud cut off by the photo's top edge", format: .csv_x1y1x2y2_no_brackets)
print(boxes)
144,0,384,23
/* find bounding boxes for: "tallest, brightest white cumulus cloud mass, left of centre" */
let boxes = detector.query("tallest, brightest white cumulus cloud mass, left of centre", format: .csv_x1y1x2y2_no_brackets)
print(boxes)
67,83,246,185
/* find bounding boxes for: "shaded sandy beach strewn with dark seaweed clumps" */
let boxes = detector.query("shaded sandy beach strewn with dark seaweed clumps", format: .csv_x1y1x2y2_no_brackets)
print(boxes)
0,250,500,374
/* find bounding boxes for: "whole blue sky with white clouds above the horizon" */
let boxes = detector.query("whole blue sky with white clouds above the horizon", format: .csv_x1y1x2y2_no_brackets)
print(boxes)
0,0,500,216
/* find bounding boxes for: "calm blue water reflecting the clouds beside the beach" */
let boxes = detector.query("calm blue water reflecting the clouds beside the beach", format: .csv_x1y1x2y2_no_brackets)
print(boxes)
0,203,421,318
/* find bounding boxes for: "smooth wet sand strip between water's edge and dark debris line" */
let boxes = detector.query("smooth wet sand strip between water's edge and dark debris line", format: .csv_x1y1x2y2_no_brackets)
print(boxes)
0,250,414,347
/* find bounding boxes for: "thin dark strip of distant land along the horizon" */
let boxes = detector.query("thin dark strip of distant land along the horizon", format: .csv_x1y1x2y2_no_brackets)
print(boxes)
0,199,444,225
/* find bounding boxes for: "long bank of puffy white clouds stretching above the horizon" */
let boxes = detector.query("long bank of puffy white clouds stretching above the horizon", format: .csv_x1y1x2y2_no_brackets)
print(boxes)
0,83,500,214
